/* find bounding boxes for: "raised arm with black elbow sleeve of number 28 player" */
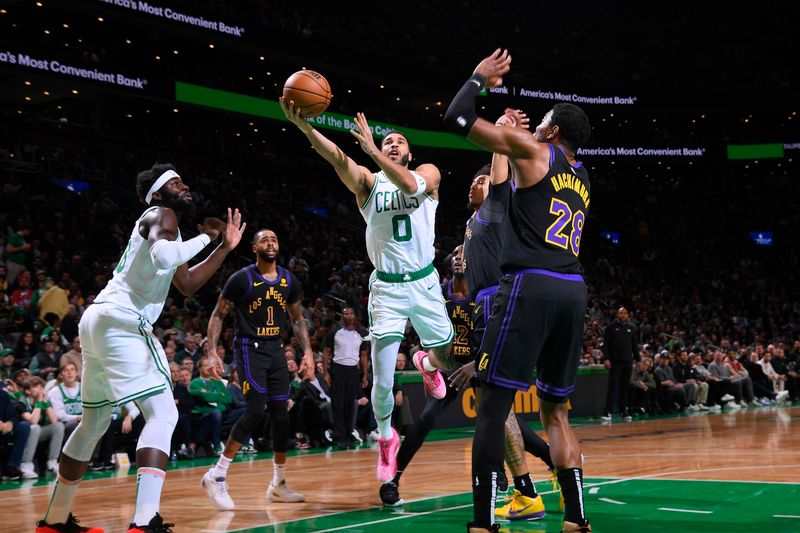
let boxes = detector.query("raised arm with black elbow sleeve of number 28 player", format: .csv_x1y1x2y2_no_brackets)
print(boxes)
444,48,548,159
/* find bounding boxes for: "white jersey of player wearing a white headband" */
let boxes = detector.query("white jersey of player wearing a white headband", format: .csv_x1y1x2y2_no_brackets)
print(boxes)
95,207,181,324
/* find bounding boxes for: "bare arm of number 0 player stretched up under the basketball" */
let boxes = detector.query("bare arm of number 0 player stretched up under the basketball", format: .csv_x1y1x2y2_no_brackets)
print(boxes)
279,96,375,205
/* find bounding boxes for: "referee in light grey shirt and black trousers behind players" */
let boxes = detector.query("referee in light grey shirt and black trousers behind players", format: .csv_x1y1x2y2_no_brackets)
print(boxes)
322,307,367,450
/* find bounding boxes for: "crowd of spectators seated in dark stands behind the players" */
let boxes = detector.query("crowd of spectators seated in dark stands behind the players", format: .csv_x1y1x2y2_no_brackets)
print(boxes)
0,106,800,478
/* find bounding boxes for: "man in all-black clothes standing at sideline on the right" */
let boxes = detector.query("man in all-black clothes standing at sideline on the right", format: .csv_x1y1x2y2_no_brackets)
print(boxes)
602,307,639,421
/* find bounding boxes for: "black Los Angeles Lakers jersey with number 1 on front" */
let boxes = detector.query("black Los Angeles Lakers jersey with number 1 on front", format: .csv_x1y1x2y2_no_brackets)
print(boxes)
222,265,300,340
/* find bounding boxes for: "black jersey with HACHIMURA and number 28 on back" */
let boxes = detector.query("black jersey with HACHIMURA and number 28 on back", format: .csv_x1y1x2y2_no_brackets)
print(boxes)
501,144,590,274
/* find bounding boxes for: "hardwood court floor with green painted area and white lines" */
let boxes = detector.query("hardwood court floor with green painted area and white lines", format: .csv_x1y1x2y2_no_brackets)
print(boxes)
6,407,800,533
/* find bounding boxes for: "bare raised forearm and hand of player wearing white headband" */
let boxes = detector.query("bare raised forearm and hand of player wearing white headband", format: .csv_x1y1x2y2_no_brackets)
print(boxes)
172,207,247,296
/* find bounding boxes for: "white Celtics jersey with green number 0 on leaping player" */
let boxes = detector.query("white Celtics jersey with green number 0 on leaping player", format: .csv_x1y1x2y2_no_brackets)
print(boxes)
361,171,439,274
